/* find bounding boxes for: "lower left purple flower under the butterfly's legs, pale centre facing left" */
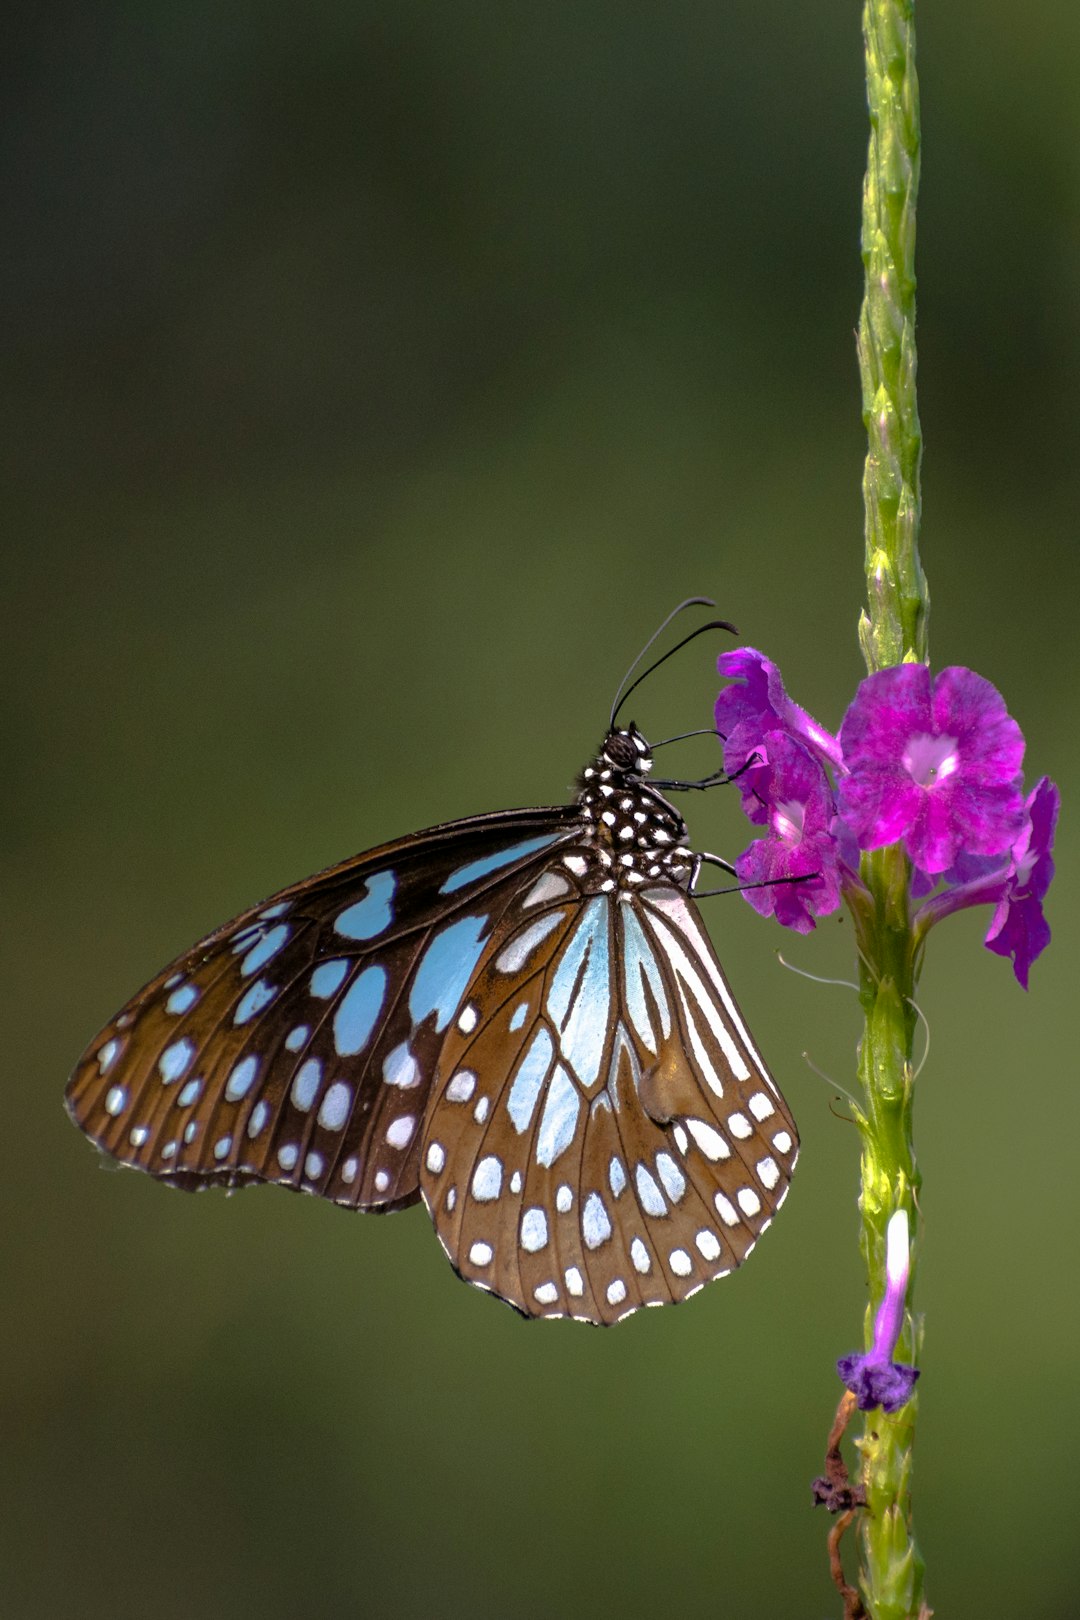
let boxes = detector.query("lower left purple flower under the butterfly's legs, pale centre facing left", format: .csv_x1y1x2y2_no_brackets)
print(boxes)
735,731,840,933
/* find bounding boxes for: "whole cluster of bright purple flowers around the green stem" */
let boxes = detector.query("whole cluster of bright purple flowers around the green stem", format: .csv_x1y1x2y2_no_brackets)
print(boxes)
716,646,1059,988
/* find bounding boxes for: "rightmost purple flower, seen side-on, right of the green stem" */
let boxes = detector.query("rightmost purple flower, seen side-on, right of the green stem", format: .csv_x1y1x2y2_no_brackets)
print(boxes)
916,776,1061,990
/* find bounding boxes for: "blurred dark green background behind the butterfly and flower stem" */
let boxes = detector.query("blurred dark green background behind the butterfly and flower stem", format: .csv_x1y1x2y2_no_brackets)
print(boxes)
0,0,1080,1620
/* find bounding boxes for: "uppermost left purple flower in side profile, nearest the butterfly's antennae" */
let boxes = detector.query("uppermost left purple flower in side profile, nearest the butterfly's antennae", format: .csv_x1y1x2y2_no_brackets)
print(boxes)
716,646,840,823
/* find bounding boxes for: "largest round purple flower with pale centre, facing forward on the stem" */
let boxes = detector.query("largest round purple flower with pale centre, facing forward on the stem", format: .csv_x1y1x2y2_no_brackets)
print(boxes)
839,664,1023,875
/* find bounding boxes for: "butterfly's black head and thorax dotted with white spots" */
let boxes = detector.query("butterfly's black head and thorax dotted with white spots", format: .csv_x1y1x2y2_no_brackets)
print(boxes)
578,724,693,893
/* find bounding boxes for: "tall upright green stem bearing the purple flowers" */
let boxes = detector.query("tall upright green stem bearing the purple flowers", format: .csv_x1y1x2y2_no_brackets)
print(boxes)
852,0,929,1620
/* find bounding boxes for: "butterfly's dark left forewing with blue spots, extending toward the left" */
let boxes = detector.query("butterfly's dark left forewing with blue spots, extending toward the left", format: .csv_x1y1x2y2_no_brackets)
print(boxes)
66,807,575,1210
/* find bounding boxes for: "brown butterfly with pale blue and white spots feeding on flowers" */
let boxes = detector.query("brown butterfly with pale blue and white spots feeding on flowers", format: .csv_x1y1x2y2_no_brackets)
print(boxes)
66,598,798,1324
